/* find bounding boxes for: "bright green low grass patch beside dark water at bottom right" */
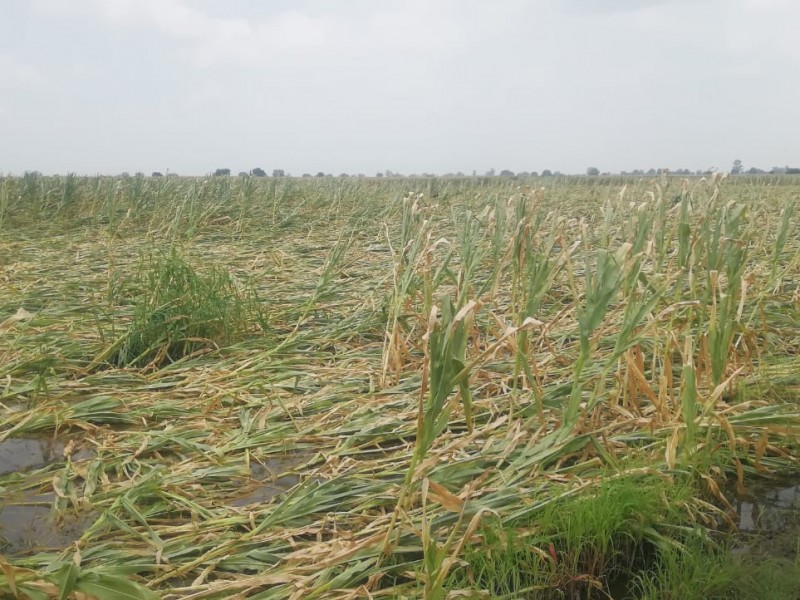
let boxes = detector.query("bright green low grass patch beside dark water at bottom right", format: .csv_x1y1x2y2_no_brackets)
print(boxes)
449,476,692,599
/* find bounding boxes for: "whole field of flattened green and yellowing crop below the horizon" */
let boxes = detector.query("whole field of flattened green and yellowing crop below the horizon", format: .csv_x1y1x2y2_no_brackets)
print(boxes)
0,174,800,600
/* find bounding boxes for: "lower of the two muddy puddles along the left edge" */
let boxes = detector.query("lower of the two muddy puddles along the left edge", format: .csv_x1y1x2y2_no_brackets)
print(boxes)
0,494,97,556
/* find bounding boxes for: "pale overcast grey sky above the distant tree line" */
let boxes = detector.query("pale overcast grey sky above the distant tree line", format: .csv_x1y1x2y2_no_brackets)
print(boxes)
0,0,800,175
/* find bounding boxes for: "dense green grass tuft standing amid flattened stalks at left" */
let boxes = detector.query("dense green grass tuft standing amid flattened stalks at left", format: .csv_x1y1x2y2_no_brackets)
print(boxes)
105,250,267,367
